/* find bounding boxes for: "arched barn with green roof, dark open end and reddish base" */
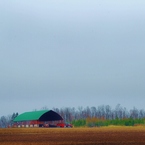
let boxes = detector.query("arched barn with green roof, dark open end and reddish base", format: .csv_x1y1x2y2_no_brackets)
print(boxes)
13,110,63,127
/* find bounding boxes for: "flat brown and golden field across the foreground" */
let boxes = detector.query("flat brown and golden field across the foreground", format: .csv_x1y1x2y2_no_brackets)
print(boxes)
0,126,145,145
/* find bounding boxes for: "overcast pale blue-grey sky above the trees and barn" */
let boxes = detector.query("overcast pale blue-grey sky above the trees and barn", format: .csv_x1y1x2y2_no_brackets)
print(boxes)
0,0,145,116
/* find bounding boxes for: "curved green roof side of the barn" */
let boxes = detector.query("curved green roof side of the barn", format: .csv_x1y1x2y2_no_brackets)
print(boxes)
14,110,49,122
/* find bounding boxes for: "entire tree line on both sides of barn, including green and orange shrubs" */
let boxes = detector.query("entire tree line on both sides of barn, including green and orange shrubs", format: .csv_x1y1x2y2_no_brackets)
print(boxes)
0,104,145,128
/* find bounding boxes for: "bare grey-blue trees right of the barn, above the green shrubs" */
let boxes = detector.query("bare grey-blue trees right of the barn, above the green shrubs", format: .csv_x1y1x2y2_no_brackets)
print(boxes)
53,104,145,122
